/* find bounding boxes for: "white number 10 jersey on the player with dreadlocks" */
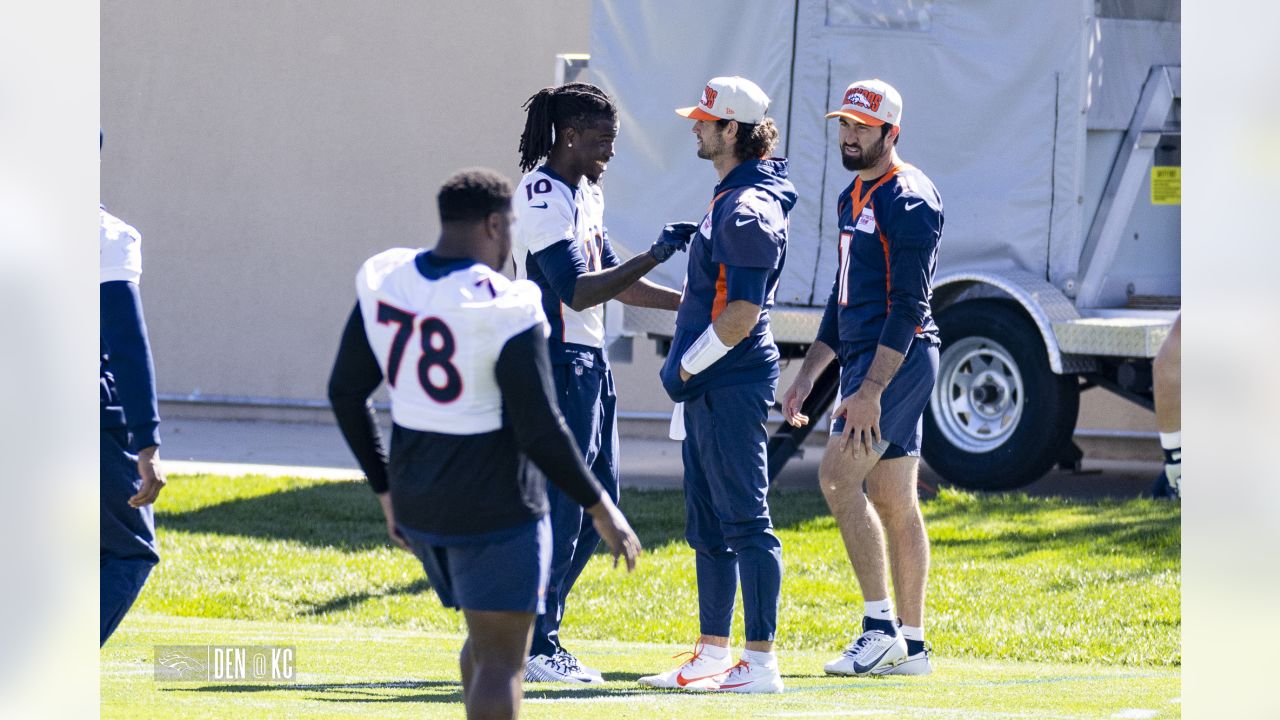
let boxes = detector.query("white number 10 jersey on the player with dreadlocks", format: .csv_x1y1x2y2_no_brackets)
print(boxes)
511,168,617,347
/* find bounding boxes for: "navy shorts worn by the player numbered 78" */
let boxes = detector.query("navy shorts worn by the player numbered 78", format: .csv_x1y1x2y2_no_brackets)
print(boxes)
399,515,552,615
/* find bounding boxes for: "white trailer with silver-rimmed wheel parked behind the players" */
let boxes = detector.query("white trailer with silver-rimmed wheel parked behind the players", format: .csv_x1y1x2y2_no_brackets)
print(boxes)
590,0,1181,489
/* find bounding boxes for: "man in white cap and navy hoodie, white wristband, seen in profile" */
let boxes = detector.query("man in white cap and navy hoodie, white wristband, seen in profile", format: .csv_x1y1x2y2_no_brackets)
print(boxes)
640,77,796,693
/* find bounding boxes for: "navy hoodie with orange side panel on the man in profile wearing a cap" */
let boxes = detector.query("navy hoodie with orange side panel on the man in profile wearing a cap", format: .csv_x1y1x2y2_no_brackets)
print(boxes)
659,158,796,402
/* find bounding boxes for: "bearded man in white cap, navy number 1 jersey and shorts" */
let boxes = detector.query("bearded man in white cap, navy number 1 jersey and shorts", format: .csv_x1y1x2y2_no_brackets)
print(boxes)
782,79,942,675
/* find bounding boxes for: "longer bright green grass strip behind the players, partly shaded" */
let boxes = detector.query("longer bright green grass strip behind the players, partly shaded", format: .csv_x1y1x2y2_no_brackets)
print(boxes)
137,475,1181,667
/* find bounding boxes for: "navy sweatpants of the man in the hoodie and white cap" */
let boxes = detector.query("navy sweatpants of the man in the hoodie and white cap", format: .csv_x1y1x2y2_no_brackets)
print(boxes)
682,380,782,642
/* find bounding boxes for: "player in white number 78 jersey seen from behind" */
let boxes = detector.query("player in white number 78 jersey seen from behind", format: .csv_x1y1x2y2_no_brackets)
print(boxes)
329,169,640,717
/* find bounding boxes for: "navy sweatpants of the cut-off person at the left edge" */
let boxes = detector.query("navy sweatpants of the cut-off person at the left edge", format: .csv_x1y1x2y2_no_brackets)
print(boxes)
99,429,160,646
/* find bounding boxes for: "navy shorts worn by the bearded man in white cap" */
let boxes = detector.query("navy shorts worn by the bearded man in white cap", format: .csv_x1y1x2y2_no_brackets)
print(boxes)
831,341,938,460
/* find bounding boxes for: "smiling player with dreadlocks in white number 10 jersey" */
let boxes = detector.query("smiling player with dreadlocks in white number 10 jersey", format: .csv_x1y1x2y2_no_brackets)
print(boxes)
513,82,694,683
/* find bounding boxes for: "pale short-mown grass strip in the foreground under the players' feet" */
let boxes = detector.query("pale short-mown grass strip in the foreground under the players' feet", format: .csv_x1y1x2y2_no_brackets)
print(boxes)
102,614,1179,720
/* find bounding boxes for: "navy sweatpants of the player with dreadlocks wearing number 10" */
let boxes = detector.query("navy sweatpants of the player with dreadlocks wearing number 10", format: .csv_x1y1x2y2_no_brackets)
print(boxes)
529,348,618,656
